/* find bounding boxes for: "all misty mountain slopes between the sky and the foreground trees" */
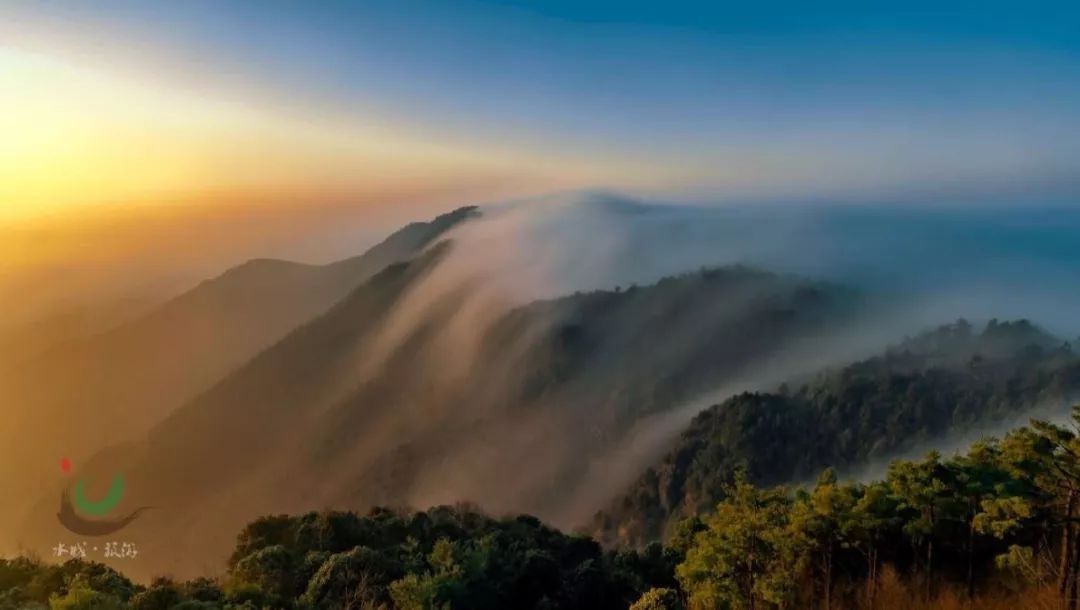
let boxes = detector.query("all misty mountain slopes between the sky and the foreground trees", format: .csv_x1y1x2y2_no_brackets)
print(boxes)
4,194,1080,591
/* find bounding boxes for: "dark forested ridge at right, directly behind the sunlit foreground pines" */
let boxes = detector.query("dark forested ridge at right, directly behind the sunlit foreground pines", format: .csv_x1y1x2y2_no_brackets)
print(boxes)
592,321,1080,545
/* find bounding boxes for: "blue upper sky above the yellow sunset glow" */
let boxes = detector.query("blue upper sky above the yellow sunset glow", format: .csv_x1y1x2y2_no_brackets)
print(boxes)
0,0,1080,211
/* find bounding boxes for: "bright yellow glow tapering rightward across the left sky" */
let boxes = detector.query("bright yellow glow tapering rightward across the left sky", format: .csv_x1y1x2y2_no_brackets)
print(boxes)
0,49,600,221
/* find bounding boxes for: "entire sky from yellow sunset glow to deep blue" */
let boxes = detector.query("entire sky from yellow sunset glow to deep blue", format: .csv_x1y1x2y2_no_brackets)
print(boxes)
0,0,1080,321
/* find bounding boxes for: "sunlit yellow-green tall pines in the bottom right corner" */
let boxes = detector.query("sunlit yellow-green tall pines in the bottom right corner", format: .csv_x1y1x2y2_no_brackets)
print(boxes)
676,407,1080,609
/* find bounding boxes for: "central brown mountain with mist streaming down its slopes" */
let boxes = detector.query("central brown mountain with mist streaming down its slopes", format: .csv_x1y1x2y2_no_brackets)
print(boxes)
23,253,861,573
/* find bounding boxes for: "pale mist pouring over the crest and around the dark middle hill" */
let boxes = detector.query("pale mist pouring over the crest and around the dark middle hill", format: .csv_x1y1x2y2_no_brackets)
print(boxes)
332,193,1080,518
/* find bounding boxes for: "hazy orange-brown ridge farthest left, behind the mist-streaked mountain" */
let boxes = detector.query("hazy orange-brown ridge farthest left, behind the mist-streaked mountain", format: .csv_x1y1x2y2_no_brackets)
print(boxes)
0,208,474,533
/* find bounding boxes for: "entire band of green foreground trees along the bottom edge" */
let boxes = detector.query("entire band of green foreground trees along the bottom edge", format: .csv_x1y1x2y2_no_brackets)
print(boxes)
10,406,1080,610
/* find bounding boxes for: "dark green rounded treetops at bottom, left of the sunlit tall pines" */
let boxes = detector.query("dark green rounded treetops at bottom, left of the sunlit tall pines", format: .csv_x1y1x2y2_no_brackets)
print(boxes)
0,506,677,610
